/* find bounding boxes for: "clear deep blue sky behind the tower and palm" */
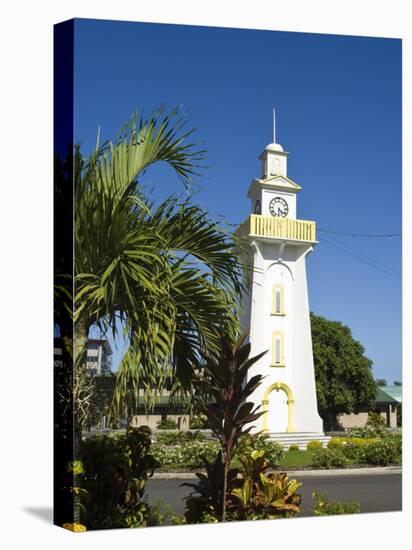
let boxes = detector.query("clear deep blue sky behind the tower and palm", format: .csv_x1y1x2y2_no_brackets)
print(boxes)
75,20,402,382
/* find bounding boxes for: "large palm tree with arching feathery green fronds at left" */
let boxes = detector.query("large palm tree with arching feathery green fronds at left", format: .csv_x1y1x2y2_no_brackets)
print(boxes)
57,109,240,443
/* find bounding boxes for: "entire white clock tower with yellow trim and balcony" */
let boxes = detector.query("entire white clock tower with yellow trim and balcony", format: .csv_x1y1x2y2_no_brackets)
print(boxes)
239,114,329,447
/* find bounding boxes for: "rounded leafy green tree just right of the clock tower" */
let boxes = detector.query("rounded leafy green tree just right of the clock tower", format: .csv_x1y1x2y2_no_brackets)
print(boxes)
311,313,377,430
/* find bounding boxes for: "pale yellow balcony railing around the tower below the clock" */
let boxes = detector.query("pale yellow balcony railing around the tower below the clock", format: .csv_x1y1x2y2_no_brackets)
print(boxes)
242,214,316,242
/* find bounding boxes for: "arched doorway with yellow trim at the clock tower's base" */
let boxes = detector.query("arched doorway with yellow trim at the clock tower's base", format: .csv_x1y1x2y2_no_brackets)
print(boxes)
262,382,295,433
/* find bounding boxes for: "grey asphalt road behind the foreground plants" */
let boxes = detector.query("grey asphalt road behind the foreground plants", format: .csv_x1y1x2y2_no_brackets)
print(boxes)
146,474,402,516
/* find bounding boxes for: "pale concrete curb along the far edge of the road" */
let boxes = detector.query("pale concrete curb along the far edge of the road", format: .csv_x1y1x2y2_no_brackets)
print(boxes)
150,466,402,480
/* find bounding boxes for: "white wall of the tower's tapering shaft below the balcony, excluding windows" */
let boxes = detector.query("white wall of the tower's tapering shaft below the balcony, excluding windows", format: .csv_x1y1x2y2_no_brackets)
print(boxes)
244,239,323,433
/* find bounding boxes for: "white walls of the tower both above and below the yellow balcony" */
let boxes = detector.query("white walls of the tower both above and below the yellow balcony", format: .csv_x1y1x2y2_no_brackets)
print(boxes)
241,140,323,434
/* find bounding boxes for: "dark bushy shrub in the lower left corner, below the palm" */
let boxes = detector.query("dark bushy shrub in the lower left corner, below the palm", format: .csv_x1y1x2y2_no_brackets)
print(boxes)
81,426,159,529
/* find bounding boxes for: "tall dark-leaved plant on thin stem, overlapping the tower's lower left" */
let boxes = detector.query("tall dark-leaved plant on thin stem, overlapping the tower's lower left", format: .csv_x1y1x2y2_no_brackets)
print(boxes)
193,334,266,521
